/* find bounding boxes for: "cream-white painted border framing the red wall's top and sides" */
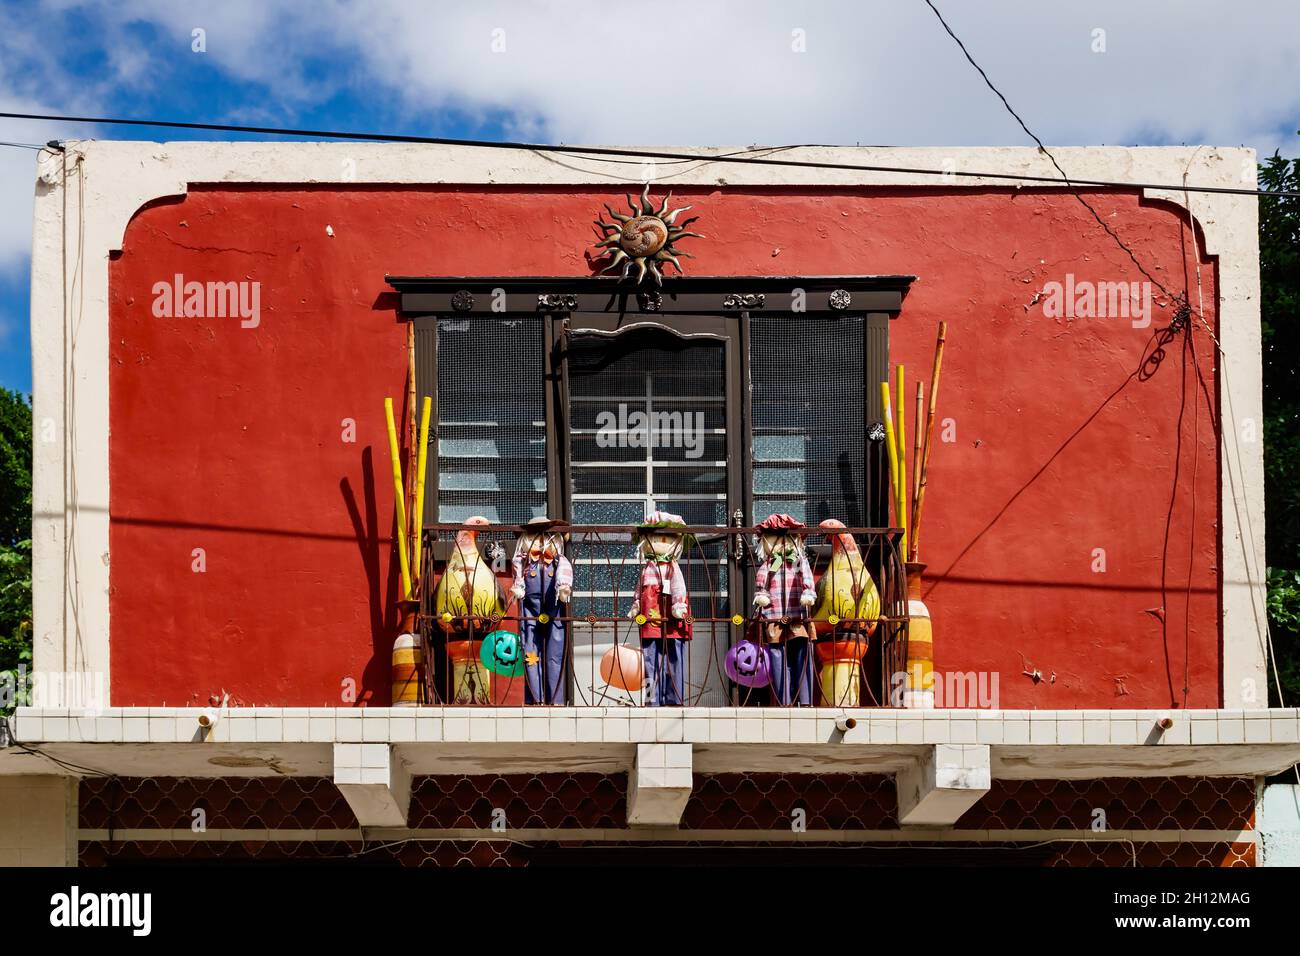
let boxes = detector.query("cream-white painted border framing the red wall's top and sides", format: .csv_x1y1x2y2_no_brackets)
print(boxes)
31,140,1268,719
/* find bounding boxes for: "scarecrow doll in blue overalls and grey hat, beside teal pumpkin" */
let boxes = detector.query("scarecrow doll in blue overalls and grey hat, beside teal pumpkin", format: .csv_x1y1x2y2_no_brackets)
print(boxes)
510,518,573,704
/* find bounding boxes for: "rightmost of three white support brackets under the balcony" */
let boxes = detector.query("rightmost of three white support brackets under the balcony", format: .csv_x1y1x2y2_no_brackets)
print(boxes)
894,744,993,827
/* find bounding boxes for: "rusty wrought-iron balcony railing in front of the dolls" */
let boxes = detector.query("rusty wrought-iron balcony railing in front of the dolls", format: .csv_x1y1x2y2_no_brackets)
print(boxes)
413,524,909,706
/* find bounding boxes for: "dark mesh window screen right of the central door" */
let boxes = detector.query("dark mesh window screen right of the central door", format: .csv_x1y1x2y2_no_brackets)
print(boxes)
750,316,868,527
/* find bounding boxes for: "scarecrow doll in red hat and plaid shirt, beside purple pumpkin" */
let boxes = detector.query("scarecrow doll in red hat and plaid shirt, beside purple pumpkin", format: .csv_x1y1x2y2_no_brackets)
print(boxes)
754,515,816,705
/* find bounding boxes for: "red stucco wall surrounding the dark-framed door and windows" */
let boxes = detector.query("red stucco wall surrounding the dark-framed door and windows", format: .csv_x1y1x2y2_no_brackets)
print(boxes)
109,187,1221,708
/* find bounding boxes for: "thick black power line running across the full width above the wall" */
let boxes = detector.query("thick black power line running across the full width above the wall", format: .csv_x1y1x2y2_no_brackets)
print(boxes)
0,113,1300,199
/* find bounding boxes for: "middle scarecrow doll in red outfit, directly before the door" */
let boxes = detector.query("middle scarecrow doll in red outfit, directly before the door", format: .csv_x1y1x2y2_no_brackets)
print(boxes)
628,511,693,708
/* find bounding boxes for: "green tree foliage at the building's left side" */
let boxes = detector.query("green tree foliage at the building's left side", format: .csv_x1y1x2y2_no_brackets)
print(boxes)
0,388,31,704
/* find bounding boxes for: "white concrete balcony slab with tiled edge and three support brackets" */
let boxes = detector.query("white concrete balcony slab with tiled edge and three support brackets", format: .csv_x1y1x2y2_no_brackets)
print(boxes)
0,708,1300,829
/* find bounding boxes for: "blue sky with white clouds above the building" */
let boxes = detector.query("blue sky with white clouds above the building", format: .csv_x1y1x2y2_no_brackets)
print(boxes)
0,0,1300,392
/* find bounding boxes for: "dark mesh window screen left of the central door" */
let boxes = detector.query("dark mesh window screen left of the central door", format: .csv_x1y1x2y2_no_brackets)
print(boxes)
438,317,546,524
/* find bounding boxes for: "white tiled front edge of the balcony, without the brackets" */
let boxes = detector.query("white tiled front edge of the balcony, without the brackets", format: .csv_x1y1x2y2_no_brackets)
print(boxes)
13,706,1300,747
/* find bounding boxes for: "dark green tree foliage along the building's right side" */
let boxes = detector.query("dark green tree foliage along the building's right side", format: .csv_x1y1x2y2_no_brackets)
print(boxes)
1260,153,1300,706
